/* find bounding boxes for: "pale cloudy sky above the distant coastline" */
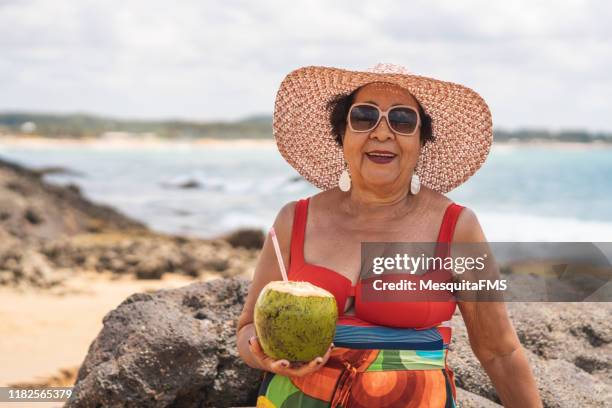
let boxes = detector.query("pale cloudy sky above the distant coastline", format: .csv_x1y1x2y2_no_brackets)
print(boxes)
0,0,612,132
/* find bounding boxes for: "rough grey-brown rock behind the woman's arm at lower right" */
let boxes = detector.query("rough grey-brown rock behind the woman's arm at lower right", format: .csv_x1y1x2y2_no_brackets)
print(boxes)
449,303,612,408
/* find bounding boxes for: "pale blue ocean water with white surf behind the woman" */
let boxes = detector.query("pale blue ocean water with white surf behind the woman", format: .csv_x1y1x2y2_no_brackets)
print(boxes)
0,142,612,242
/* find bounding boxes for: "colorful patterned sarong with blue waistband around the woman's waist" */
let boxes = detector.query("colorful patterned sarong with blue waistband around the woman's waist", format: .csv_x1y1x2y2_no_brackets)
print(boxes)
257,316,456,408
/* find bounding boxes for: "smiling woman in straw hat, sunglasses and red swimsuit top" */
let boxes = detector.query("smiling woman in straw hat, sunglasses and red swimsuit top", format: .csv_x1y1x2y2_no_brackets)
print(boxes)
237,65,541,408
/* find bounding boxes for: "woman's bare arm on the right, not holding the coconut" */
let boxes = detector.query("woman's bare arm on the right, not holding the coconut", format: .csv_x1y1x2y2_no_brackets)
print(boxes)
453,208,542,408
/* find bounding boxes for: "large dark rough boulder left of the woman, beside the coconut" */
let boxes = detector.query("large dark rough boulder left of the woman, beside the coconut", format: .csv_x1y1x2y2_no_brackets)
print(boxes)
66,279,261,407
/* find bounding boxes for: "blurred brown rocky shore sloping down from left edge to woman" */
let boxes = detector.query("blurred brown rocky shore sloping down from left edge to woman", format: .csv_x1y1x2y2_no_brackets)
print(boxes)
0,160,263,289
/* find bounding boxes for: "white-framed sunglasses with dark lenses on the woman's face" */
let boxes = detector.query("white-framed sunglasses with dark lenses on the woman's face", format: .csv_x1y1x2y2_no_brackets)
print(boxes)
347,103,421,136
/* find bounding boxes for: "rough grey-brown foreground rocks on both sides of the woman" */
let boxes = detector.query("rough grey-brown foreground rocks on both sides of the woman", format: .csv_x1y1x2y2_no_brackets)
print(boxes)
69,278,612,408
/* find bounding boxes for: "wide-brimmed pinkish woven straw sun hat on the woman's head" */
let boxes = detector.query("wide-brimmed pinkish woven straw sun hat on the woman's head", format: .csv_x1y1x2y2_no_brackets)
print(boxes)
273,64,493,193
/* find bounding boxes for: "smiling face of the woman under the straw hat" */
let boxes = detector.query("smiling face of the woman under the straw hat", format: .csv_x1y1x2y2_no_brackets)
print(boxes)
343,83,421,193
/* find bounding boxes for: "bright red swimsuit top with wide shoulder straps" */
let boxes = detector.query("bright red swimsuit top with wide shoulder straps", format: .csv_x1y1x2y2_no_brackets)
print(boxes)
288,198,463,329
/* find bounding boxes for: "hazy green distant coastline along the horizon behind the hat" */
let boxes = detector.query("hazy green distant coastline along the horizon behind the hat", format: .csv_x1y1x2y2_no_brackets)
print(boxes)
0,112,612,143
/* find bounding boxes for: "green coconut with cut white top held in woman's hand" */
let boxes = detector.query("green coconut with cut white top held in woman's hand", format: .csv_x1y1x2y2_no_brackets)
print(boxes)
254,281,338,362
